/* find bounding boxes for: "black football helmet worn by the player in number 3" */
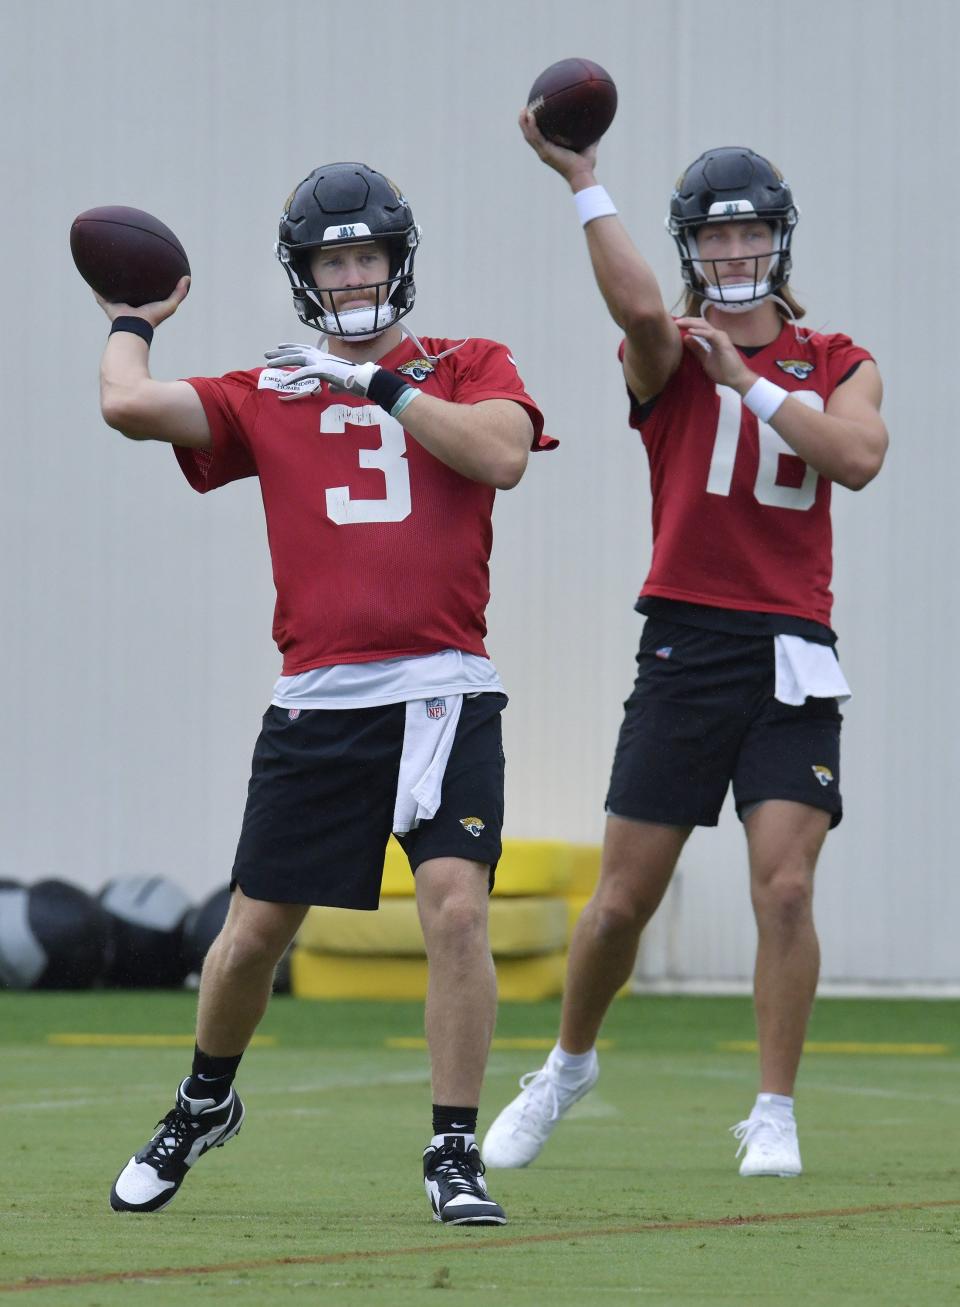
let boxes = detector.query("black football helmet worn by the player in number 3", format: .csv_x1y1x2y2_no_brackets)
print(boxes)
276,163,421,340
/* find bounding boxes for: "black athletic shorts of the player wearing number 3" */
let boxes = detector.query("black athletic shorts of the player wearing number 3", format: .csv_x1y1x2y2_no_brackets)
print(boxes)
232,694,507,911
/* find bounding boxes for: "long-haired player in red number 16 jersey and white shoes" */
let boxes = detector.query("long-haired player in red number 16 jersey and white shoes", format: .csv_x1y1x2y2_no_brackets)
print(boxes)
483,127,887,1176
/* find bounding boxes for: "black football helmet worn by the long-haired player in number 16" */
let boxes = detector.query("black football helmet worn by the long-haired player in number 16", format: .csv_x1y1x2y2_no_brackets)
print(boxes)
666,145,799,312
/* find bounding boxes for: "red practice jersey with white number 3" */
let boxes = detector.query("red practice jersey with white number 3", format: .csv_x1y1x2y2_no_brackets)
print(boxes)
175,337,547,676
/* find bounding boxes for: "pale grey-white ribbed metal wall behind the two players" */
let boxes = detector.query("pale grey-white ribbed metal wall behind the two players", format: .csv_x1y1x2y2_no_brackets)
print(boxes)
0,0,960,985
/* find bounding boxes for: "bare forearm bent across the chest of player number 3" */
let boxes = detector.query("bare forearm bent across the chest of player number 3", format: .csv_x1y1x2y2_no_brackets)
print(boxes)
402,395,533,490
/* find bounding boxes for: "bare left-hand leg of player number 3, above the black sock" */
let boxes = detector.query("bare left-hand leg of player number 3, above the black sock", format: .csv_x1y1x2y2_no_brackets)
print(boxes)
197,886,307,1057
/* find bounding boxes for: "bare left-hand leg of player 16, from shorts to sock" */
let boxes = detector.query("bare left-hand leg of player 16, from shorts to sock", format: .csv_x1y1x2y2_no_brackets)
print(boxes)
560,816,690,1053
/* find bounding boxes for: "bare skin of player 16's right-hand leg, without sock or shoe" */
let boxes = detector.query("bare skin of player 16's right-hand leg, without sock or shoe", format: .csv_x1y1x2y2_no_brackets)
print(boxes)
744,800,831,1095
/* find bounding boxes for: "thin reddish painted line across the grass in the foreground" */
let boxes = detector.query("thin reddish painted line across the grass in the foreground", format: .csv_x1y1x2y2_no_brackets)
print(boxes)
0,1199,960,1294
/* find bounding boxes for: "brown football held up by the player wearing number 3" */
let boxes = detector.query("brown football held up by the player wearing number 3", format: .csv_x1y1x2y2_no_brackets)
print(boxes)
71,204,189,308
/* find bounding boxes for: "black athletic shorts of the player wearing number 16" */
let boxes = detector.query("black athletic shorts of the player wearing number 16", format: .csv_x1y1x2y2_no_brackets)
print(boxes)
606,617,842,826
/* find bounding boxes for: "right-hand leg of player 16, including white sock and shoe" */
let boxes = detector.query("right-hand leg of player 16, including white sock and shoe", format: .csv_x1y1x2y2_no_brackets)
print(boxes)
733,799,831,1176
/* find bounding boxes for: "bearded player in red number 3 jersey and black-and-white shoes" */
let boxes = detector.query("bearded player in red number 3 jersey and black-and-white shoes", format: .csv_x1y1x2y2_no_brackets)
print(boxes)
101,163,555,1225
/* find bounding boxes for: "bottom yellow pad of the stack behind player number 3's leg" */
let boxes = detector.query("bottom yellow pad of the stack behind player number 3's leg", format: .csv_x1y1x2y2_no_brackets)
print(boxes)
290,948,566,1002
